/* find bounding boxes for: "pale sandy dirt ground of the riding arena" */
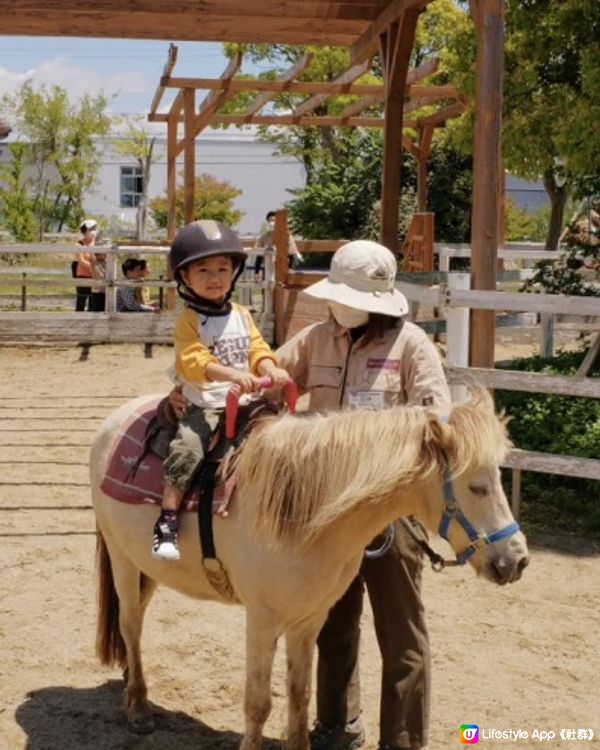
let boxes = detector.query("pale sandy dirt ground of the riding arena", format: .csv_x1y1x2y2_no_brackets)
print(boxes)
0,345,600,750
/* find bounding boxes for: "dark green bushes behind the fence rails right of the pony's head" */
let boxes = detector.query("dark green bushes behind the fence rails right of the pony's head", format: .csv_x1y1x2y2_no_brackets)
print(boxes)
496,352,600,533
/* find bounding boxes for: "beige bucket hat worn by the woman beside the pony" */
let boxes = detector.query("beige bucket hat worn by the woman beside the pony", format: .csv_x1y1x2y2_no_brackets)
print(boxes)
304,240,408,318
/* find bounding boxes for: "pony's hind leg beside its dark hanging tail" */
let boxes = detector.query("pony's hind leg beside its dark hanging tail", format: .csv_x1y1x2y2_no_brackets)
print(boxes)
111,552,156,734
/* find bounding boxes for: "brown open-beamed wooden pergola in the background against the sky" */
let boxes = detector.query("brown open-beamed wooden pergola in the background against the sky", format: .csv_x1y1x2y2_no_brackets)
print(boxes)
148,45,467,242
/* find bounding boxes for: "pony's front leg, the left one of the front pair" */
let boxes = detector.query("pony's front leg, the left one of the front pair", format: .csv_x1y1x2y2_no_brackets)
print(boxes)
240,609,281,750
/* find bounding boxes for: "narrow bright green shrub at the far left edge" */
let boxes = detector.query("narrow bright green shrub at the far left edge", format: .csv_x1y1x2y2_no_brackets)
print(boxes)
0,143,35,242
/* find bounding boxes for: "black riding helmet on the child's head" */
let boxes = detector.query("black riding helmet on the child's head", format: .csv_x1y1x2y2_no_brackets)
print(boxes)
169,219,248,281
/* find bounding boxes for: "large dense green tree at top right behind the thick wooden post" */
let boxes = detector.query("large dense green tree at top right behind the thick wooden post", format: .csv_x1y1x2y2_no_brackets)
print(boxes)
449,0,600,249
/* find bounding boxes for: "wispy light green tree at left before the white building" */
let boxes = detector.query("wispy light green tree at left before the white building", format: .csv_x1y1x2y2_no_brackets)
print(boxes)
3,81,110,239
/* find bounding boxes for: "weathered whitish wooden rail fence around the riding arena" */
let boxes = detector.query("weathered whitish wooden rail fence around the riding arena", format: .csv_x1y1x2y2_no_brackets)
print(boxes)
0,241,600,515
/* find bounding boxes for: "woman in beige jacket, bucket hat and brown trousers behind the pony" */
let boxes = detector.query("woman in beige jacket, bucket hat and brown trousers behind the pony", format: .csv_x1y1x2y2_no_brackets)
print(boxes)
277,240,450,750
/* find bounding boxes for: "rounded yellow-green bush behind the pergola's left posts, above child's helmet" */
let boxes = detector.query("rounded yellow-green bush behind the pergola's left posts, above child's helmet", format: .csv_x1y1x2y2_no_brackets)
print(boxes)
149,174,242,229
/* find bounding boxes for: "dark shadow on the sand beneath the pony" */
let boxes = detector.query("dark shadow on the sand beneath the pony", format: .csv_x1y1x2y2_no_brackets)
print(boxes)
16,680,281,750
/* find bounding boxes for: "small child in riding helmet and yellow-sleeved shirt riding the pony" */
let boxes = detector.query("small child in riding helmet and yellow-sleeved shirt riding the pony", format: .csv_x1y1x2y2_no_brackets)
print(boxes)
152,221,289,560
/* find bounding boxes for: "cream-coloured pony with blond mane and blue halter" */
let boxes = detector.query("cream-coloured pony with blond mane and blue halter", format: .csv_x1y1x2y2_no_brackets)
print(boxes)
91,391,528,750
